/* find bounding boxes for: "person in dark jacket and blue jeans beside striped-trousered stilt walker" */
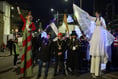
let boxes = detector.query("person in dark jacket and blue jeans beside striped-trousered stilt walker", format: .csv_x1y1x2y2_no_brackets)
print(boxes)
37,34,52,79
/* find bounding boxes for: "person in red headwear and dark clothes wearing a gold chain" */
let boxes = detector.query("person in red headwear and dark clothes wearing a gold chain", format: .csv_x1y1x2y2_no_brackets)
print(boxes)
53,33,66,76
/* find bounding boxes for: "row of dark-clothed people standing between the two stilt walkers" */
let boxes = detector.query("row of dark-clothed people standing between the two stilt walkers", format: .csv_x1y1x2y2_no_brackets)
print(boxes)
32,31,89,77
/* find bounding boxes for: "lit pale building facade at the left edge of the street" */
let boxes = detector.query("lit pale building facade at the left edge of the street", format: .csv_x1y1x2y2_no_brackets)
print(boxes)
0,1,11,45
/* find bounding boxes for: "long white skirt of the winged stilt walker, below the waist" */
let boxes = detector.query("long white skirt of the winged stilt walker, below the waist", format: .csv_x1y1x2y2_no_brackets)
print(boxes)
90,26,107,56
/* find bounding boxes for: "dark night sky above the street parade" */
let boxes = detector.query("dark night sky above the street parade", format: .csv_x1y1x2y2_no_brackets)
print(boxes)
2,0,118,24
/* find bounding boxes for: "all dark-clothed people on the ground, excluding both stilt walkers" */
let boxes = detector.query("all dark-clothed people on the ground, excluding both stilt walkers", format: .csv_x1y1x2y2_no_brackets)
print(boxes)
4,28,118,78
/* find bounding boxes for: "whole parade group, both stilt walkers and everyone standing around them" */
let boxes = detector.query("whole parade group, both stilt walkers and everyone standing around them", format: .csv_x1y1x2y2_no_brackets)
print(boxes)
4,5,118,78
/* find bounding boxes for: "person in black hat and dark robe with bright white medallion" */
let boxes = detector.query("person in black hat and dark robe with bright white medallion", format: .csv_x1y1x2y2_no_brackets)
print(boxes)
67,31,79,73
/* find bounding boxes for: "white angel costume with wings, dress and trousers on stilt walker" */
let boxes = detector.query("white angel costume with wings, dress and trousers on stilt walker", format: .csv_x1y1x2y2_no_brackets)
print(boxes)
73,4,114,76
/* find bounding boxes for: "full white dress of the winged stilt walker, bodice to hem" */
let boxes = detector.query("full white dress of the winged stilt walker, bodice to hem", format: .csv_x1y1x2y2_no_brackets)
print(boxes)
90,17,107,59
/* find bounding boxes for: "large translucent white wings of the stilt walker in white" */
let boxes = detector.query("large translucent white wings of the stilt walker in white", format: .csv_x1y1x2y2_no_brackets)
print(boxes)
73,4,115,46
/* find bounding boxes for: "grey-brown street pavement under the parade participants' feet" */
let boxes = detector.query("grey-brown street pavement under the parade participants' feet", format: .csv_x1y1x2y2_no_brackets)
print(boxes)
0,51,118,79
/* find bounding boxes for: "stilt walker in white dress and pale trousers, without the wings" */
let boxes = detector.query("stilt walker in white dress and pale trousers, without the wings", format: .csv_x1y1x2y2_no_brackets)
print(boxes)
88,12,113,78
